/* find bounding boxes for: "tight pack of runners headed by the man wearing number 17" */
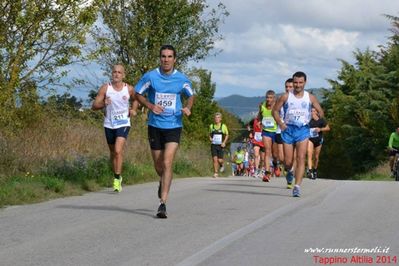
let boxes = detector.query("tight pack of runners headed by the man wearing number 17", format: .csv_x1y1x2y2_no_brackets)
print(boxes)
223,75,330,197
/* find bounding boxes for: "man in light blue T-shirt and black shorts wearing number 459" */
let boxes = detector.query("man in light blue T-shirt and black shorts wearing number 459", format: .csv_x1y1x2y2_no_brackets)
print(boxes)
135,45,194,218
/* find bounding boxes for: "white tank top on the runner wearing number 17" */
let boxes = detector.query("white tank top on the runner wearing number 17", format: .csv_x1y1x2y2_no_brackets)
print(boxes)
284,91,312,127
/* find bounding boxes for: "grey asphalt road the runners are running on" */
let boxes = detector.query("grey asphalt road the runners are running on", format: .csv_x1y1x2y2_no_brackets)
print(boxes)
0,177,399,266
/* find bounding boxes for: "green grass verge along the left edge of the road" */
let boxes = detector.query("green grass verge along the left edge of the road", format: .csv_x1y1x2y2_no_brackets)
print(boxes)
0,156,216,207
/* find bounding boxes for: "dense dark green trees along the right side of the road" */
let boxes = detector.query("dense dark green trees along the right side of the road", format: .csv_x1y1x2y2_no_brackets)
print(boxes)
321,16,399,178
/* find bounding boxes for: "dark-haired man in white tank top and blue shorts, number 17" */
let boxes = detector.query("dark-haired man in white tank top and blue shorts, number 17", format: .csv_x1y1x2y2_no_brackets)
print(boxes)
273,72,324,197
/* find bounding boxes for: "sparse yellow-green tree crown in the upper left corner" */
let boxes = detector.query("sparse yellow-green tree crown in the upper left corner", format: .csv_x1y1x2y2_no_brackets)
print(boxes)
0,0,97,128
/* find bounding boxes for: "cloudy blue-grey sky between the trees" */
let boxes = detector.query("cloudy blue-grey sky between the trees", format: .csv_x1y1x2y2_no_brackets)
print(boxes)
69,0,399,98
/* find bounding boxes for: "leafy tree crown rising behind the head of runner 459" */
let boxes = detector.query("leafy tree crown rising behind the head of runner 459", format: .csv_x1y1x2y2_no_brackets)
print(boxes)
95,0,228,84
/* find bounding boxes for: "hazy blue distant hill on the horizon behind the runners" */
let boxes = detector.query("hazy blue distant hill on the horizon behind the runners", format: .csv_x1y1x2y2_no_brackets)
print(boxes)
216,89,323,122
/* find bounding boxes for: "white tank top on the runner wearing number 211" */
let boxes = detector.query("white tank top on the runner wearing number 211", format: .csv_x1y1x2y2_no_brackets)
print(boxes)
104,83,130,129
